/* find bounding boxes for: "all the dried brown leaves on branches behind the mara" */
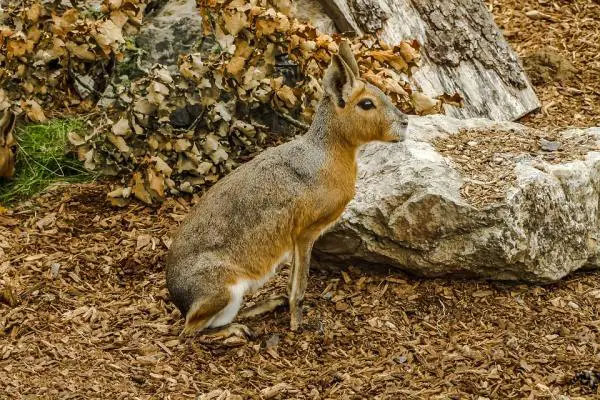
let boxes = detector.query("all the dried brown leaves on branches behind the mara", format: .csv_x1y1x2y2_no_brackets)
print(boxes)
0,0,462,206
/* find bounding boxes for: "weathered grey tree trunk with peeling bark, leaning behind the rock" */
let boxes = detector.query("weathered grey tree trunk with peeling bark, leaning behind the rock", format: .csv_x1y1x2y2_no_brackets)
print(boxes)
299,0,540,120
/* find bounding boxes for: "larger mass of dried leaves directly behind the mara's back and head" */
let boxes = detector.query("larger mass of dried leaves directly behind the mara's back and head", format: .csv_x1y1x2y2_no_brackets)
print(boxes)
78,0,461,206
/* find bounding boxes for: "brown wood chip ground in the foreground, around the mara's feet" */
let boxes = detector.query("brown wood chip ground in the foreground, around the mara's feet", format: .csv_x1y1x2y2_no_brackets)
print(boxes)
0,184,600,399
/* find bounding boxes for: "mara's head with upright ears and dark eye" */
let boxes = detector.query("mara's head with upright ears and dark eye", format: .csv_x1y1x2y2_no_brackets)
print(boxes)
323,41,408,145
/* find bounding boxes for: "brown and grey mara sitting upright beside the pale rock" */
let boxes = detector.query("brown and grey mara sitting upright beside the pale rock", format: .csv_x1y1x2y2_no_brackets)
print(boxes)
167,43,407,332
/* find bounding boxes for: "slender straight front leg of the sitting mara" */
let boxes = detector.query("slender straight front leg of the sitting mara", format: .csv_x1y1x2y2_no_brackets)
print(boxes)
288,237,315,331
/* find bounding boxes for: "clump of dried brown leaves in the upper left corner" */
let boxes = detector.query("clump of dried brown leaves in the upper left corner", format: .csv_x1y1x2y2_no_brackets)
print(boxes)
0,0,147,122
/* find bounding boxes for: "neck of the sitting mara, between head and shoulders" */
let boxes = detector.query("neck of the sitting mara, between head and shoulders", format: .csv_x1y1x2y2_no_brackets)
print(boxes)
306,98,360,165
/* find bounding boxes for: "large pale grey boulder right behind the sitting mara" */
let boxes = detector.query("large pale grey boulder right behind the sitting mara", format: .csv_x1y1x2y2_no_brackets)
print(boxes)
315,115,600,282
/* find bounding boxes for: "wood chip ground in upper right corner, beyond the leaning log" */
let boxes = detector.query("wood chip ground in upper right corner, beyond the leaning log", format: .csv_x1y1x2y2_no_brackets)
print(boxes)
487,0,600,127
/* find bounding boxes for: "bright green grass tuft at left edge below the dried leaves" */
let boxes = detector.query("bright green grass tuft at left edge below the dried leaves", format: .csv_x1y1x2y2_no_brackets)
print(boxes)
0,119,94,205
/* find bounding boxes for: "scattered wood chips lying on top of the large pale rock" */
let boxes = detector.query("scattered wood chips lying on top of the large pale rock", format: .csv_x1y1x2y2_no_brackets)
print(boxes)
432,129,600,207
